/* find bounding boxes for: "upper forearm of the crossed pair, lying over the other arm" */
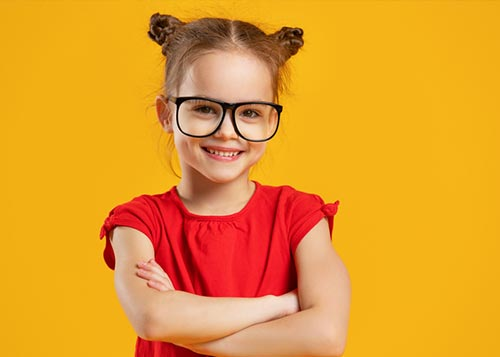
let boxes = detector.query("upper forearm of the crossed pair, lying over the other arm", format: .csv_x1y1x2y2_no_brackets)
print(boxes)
116,273,296,345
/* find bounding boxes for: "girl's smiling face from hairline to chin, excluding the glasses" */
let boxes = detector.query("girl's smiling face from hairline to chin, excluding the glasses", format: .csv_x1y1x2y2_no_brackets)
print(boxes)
166,51,274,183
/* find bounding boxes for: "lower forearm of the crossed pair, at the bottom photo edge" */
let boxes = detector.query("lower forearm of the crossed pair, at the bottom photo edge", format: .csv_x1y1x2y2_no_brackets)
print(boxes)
189,308,346,357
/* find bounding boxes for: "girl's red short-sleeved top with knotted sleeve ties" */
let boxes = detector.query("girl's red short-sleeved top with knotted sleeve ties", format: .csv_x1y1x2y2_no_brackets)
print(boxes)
100,182,339,357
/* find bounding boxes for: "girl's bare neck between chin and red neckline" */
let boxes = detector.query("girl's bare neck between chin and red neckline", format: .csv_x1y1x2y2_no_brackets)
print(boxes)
177,174,255,216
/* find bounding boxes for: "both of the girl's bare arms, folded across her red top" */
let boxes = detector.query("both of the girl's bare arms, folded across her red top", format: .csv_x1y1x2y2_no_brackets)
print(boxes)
111,220,350,357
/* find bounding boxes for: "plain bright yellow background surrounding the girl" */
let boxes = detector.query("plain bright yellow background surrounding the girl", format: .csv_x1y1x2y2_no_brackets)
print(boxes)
0,0,500,357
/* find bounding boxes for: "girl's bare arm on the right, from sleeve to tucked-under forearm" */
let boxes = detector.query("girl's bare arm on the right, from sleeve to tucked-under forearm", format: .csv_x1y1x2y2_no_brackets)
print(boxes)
184,220,350,357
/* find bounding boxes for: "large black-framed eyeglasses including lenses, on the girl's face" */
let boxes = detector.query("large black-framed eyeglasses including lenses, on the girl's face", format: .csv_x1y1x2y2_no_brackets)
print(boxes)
168,96,283,142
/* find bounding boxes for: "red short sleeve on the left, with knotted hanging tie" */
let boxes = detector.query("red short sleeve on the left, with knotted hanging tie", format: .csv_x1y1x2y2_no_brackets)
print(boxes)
99,195,158,269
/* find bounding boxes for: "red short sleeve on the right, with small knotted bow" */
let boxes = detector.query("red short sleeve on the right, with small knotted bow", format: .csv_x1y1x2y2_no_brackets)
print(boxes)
289,193,339,254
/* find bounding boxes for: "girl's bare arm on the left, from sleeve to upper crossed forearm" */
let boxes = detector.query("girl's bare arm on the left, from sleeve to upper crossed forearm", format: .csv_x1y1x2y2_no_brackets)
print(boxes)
111,227,296,345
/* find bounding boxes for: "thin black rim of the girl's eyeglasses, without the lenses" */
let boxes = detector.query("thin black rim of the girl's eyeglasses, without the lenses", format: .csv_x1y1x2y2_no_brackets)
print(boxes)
167,95,283,143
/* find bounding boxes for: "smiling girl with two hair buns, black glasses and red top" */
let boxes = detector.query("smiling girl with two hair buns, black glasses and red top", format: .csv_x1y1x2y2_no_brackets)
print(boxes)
101,14,350,357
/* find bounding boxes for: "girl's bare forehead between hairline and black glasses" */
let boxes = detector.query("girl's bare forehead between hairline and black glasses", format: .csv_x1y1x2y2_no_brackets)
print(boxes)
178,51,274,103
